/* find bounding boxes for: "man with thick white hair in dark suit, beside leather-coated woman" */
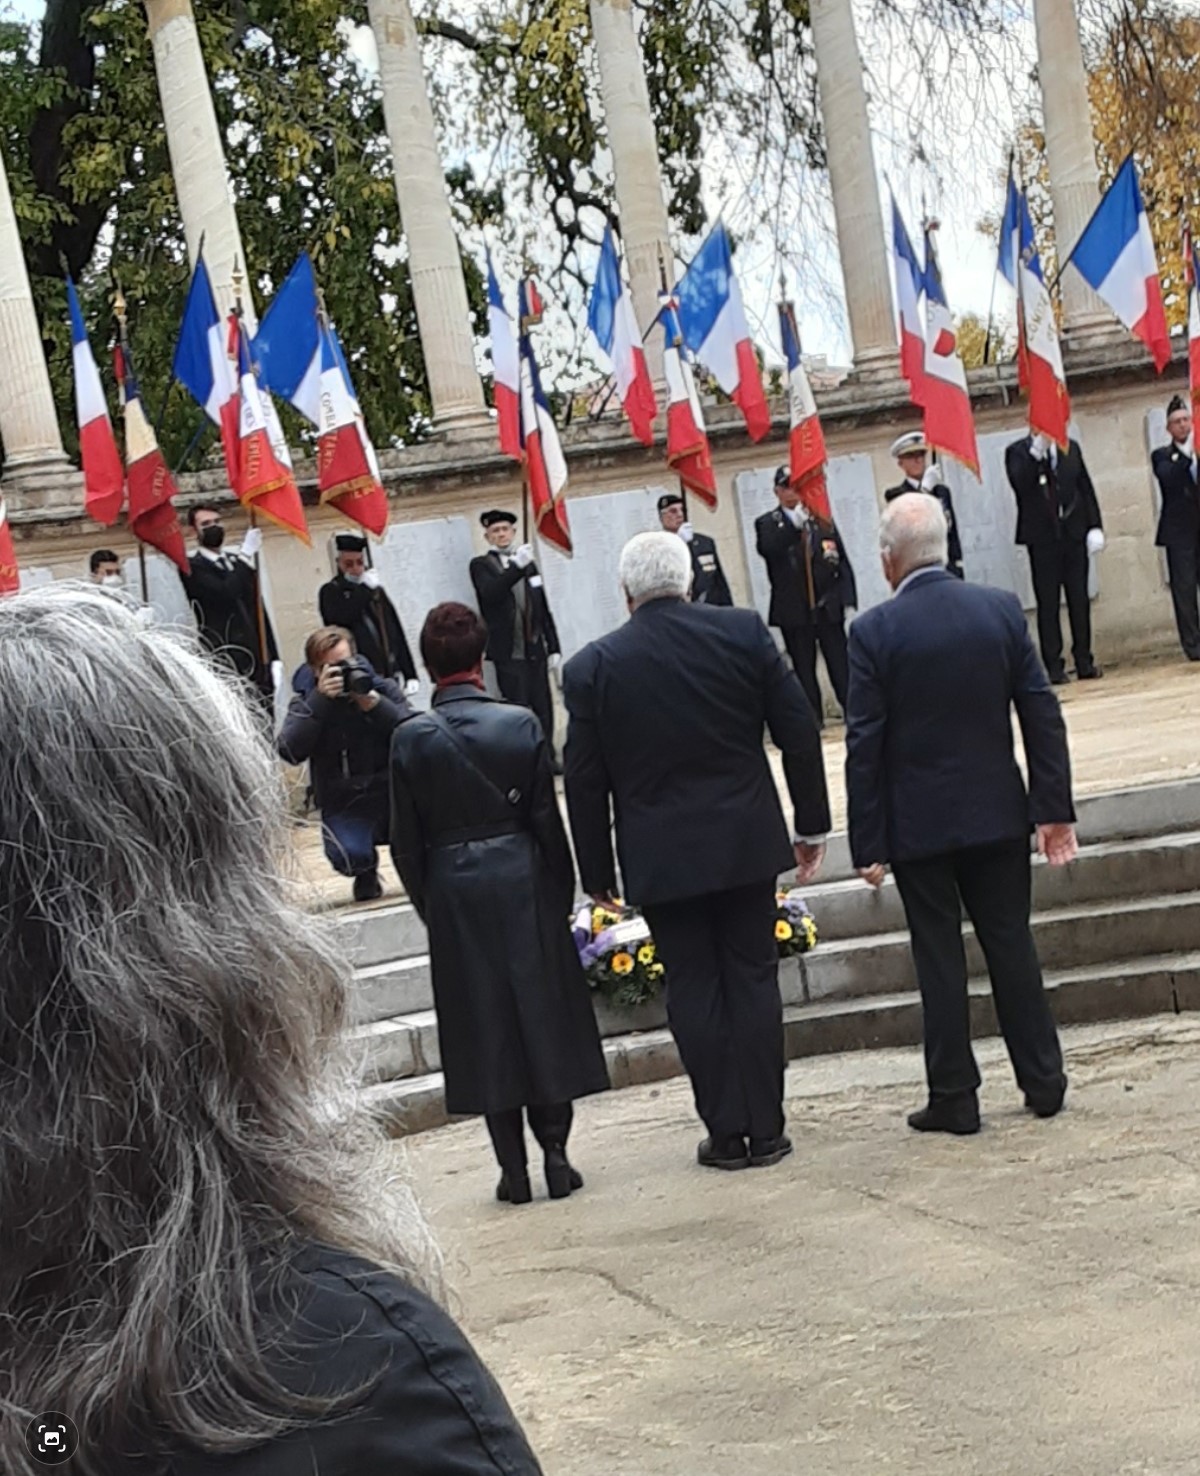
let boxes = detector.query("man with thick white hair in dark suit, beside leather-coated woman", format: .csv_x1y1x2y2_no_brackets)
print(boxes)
564,533,830,1169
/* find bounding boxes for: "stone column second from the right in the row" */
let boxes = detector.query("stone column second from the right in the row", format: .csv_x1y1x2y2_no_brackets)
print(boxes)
809,0,899,375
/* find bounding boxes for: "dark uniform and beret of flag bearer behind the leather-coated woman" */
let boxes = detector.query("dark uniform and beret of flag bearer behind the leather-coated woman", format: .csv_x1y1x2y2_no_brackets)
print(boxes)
471,512,561,756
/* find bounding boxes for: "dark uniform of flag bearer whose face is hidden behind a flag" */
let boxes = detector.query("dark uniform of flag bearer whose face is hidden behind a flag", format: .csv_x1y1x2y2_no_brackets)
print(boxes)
1004,435,1101,683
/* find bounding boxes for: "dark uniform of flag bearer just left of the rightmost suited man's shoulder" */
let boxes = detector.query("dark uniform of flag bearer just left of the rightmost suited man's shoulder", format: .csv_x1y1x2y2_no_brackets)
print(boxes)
754,508,858,723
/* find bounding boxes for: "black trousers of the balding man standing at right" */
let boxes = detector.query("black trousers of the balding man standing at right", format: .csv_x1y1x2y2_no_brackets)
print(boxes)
892,840,1063,1097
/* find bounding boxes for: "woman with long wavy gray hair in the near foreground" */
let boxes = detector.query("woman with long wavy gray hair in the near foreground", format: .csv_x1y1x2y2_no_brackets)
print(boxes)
0,587,539,1476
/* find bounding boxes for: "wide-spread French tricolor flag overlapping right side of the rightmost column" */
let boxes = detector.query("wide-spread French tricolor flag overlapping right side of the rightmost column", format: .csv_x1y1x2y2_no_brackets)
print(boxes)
1070,154,1170,373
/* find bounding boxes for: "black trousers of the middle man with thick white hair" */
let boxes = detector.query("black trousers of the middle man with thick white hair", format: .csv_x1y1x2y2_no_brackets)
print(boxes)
642,881,785,1138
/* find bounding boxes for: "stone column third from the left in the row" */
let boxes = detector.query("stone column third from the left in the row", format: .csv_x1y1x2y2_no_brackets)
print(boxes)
368,0,490,431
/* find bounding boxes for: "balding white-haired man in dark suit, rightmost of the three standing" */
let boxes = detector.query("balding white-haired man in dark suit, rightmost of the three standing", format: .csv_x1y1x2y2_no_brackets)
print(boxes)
846,496,1076,1134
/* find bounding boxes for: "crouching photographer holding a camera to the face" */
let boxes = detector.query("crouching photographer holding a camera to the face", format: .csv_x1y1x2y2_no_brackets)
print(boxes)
276,626,413,902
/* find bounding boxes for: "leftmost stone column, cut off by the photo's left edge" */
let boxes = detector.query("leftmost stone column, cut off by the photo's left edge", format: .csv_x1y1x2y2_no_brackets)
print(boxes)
0,143,68,483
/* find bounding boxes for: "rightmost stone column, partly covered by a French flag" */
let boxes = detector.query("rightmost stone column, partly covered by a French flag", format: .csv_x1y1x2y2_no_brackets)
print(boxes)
1033,0,1114,341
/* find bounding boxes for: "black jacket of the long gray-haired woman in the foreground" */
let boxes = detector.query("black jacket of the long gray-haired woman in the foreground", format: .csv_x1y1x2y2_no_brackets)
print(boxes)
162,1244,542,1476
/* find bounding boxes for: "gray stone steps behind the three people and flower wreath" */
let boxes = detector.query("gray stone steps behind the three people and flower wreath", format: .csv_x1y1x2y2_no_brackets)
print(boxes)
335,781,1200,1134
